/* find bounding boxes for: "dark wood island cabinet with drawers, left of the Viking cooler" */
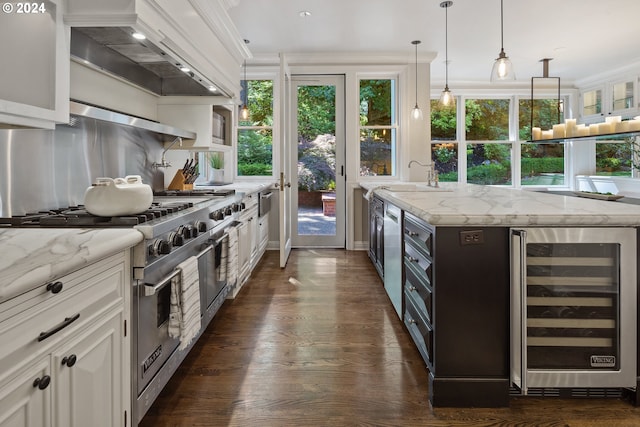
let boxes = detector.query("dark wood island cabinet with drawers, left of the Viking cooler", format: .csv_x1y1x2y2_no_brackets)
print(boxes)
403,212,510,407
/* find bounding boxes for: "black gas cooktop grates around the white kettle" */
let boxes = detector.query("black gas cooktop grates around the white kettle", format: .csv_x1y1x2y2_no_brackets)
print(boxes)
0,201,193,227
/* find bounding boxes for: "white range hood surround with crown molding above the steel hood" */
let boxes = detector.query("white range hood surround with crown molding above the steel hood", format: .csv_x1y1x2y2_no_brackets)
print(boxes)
64,0,249,98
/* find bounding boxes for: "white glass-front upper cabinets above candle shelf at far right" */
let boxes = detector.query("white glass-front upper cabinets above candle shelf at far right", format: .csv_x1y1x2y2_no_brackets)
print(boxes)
580,76,640,123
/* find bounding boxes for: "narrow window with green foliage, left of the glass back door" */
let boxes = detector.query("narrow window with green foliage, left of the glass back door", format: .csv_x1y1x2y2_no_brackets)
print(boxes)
238,80,273,176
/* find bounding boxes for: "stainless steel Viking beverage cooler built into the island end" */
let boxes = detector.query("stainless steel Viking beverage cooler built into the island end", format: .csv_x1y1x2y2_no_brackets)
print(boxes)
511,228,637,395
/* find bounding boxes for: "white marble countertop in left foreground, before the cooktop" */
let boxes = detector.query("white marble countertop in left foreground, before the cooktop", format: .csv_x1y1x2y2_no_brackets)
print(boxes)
0,228,142,302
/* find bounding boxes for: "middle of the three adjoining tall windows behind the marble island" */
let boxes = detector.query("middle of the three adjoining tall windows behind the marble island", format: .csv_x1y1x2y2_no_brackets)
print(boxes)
465,99,511,185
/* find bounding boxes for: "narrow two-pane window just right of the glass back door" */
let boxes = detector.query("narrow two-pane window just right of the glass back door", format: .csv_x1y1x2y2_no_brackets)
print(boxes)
360,79,398,176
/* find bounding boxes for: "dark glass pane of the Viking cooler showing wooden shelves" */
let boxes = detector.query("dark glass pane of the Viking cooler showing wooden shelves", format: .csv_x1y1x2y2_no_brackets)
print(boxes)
526,243,620,370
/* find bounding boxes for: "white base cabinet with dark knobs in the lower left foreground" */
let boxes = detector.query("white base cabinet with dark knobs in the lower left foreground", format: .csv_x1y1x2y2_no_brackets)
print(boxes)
0,251,131,427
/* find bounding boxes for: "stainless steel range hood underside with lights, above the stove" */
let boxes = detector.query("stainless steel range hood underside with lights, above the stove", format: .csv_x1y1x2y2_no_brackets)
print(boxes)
71,27,228,96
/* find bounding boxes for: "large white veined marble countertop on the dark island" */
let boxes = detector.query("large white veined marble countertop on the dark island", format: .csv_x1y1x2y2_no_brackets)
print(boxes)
361,182,640,226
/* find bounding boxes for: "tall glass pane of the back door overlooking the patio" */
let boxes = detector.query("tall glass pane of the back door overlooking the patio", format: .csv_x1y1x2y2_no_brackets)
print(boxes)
297,85,336,235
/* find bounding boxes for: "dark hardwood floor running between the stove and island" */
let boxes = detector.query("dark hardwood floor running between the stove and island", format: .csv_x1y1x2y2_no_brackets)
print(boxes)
140,250,640,427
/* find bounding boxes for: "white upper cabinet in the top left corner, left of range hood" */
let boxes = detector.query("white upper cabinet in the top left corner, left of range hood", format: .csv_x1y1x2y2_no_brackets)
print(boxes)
0,0,69,129
